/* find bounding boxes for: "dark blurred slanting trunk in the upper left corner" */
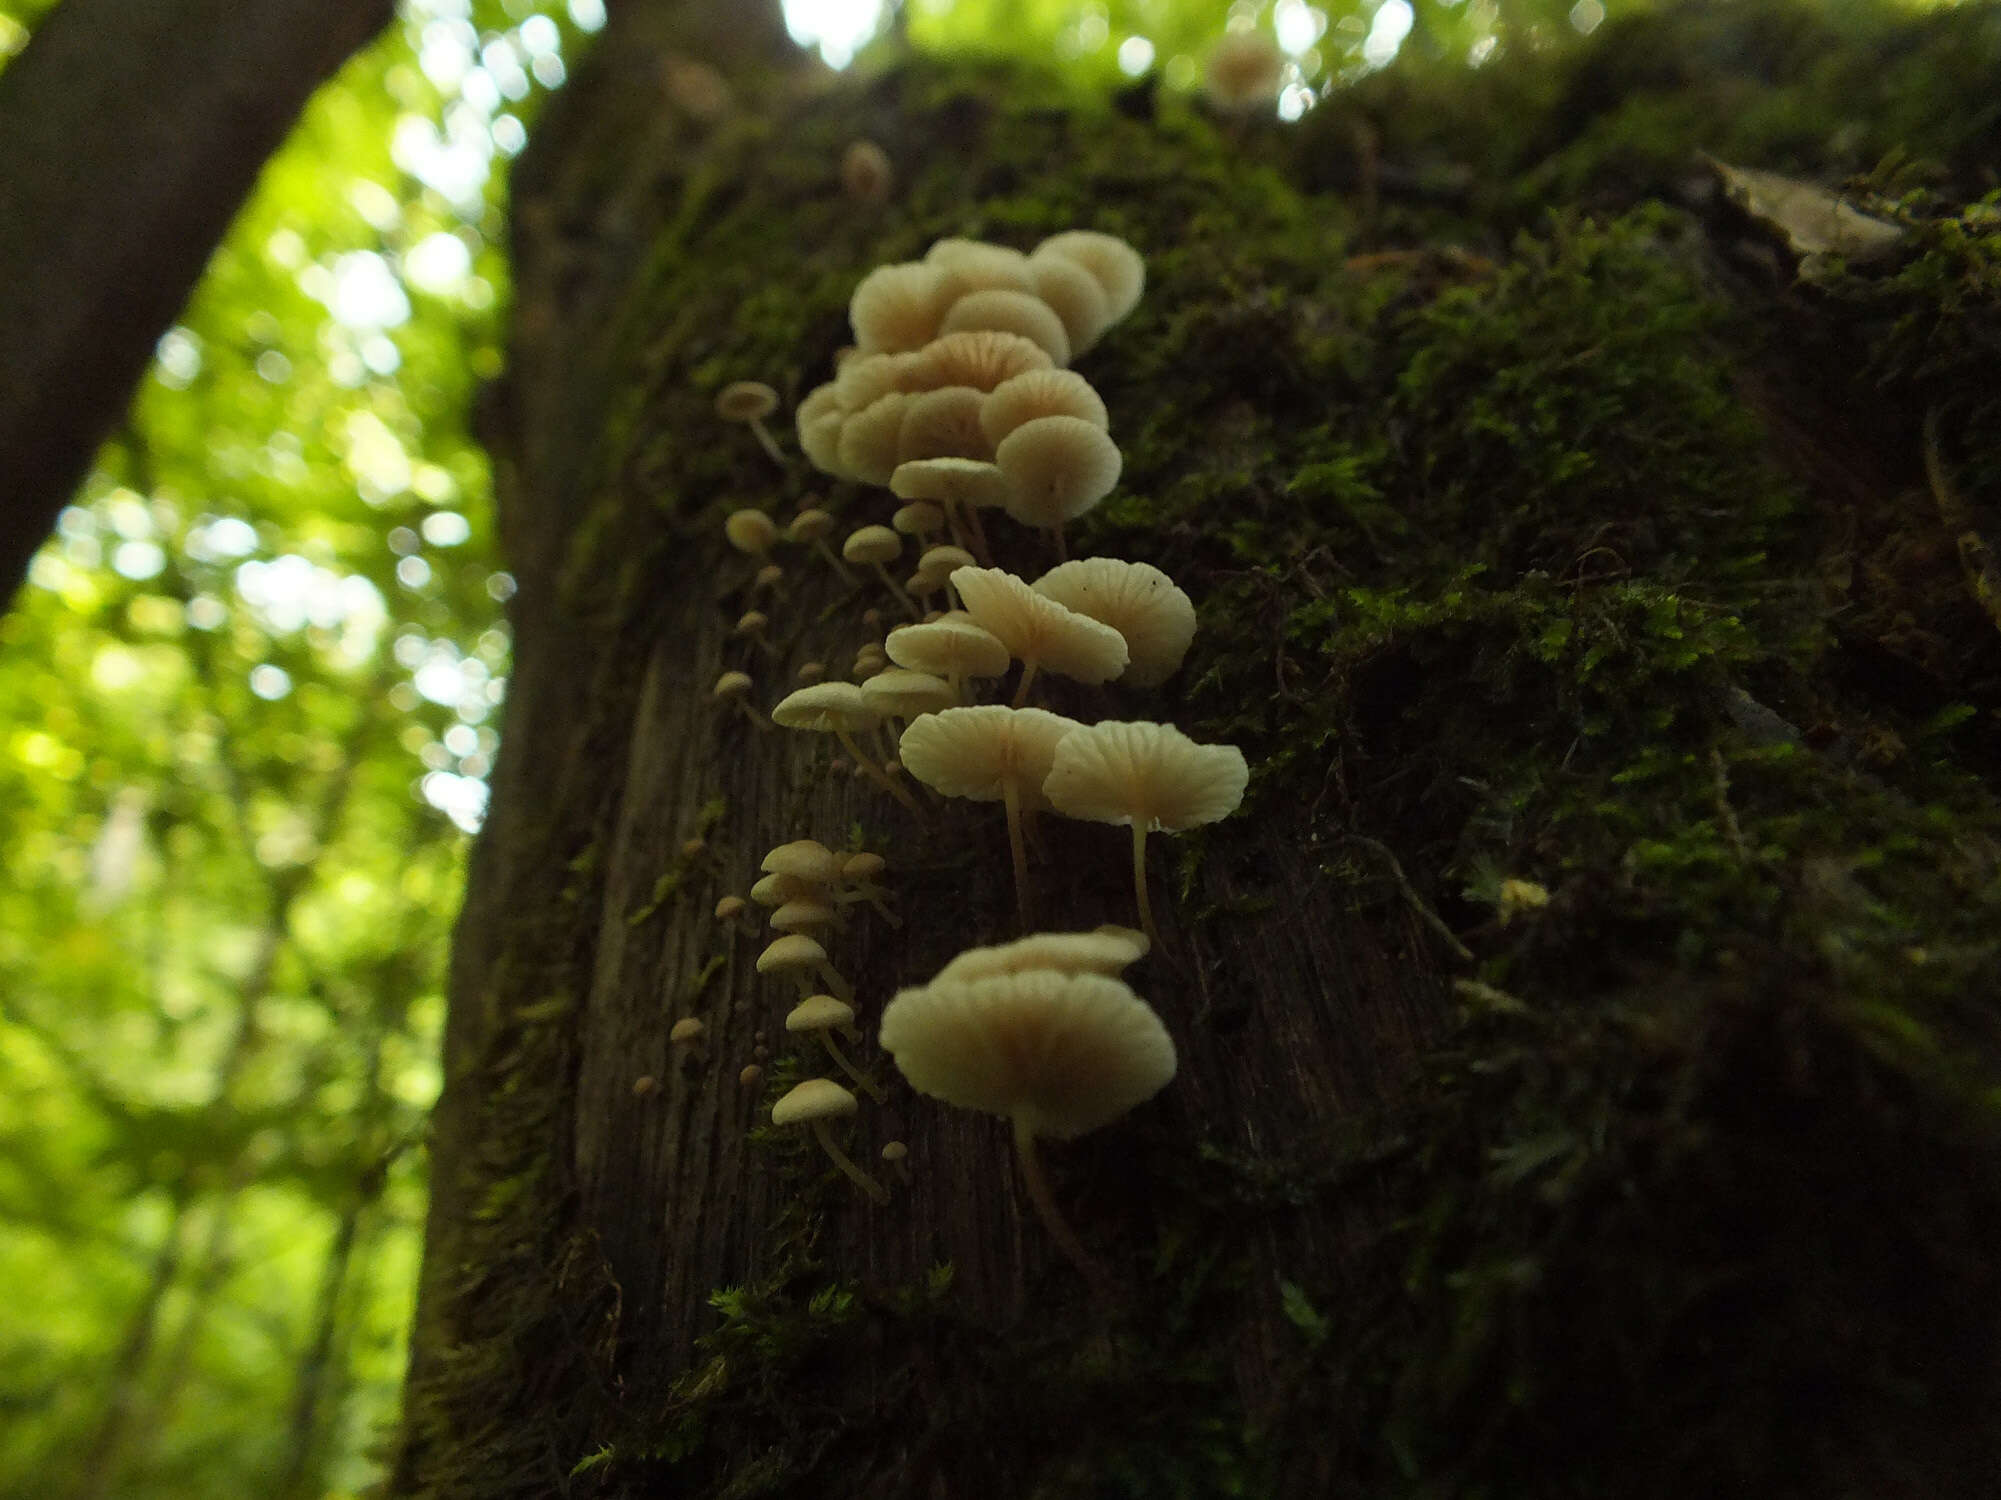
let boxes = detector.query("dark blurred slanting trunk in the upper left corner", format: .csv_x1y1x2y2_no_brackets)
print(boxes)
0,0,392,606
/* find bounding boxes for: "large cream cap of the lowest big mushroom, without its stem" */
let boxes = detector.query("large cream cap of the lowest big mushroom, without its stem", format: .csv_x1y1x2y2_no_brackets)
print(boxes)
880,970,1175,1138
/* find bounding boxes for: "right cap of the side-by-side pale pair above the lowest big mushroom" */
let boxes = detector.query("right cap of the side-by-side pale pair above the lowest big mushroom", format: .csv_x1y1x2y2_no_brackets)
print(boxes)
1043,722,1251,834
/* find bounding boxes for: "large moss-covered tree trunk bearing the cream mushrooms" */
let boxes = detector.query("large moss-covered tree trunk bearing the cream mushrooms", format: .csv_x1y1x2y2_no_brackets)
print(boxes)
394,8,2001,1496
